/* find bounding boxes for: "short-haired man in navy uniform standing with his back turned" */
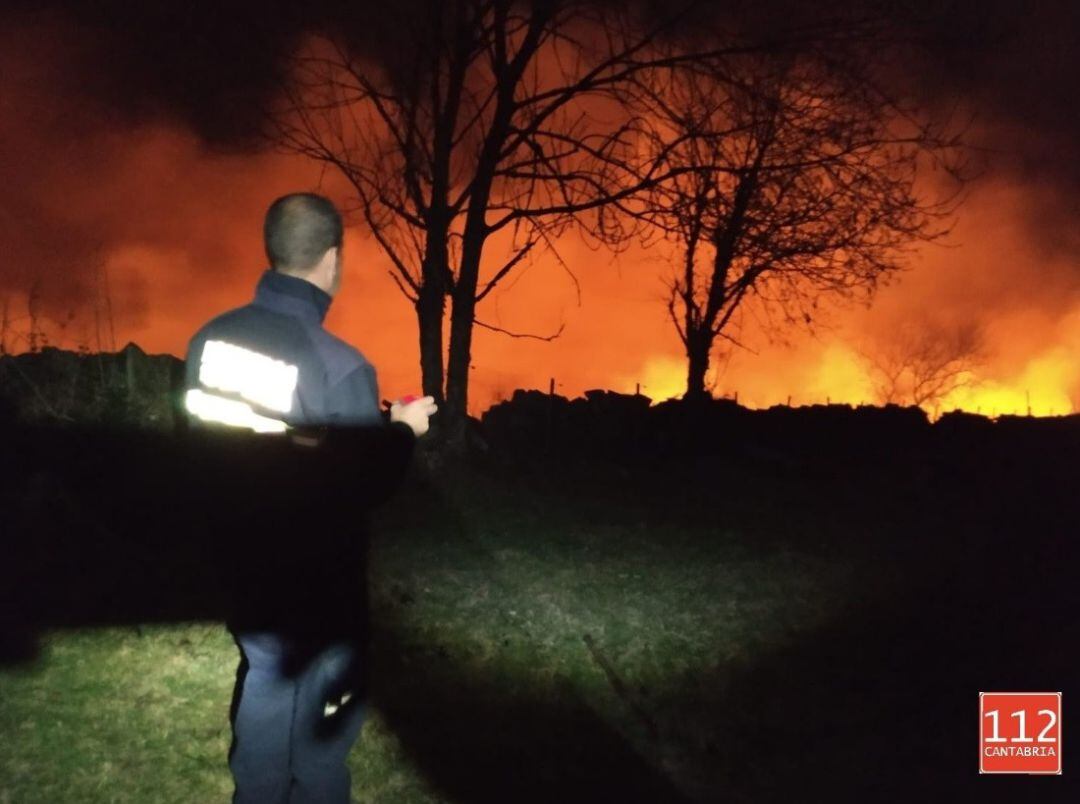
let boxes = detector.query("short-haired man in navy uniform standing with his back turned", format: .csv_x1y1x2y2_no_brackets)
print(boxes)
185,193,436,804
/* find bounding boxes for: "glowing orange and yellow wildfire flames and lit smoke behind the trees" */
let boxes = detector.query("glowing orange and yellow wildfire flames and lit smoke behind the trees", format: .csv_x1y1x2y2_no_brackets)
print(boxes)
0,12,1080,416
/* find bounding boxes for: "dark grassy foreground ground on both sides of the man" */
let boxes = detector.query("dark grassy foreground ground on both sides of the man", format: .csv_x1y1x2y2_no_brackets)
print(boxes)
0,417,1080,802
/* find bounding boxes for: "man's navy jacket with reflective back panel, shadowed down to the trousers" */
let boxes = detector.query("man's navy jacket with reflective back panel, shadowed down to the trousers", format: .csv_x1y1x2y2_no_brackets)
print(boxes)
186,270,416,637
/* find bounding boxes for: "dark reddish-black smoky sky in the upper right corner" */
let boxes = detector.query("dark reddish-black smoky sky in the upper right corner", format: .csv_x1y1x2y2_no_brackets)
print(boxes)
912,0,1080,250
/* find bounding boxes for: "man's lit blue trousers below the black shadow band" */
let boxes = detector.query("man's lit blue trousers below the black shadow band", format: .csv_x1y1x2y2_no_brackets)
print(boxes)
229,631,366,804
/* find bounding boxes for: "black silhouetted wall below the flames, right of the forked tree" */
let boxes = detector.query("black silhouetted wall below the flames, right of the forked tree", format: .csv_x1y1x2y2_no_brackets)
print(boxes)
482,389,1080,469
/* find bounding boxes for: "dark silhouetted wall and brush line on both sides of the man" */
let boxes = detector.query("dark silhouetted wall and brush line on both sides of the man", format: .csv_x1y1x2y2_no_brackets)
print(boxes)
0,344,1080,468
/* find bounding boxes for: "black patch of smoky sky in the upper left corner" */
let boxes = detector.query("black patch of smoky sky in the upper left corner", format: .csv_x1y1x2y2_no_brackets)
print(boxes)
1,0,316,149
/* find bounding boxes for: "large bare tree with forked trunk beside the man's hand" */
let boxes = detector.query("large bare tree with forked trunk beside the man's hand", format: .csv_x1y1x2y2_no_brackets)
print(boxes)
271,0,825,451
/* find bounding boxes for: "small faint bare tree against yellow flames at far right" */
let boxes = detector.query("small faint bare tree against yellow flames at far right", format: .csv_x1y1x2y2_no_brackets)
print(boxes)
859,317,986,414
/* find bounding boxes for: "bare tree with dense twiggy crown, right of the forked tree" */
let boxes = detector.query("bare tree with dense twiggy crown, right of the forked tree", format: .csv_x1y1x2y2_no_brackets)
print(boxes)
624,40,960,399
